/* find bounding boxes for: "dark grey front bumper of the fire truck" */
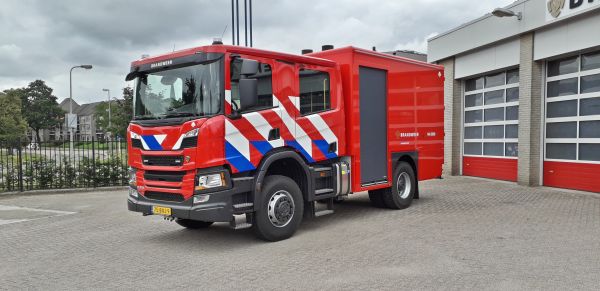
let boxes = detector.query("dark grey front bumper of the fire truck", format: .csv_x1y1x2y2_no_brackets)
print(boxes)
127,177,254,222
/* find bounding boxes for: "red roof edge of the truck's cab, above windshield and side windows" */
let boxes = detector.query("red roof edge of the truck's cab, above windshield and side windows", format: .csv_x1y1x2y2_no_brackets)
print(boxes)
131,44,336,67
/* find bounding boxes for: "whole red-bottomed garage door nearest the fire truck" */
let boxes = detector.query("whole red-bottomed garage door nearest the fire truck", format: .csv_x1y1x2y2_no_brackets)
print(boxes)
463,69,519,181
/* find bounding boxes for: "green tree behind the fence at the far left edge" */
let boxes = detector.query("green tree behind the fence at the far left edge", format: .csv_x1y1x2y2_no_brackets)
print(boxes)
0,89,27,141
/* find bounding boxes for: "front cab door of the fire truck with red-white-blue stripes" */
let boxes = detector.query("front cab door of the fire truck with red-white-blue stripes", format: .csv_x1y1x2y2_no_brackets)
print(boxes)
225,56,284,173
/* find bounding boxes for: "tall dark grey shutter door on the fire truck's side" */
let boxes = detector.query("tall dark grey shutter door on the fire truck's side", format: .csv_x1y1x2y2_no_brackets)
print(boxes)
359,67,388,185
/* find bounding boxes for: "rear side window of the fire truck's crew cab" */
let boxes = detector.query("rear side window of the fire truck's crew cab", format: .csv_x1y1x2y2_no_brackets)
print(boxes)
300,69,331,115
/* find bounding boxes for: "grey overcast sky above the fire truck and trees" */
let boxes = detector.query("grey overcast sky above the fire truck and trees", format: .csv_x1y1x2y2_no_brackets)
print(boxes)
0,0,513,104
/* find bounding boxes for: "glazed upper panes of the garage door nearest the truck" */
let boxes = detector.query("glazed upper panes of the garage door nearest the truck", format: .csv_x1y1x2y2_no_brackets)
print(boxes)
463,68,519,158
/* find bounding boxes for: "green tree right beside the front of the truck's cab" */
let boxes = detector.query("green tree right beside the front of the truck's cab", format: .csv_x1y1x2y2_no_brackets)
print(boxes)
96,87,133,138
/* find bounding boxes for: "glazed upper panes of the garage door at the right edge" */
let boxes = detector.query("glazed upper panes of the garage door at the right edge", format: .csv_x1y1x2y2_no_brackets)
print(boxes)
544,52,600,162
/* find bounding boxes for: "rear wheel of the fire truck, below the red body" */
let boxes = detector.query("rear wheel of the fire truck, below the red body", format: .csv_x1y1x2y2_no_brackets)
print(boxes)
380,162,417,209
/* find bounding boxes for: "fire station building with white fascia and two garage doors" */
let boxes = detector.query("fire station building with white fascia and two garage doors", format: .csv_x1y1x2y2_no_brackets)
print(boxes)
427,0,600,192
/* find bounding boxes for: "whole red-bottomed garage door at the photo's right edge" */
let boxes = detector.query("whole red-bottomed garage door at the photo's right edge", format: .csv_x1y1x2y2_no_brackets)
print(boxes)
544,52,600,192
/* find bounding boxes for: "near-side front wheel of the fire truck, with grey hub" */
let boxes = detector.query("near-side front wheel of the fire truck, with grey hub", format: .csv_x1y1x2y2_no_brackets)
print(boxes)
253,175,304,241
